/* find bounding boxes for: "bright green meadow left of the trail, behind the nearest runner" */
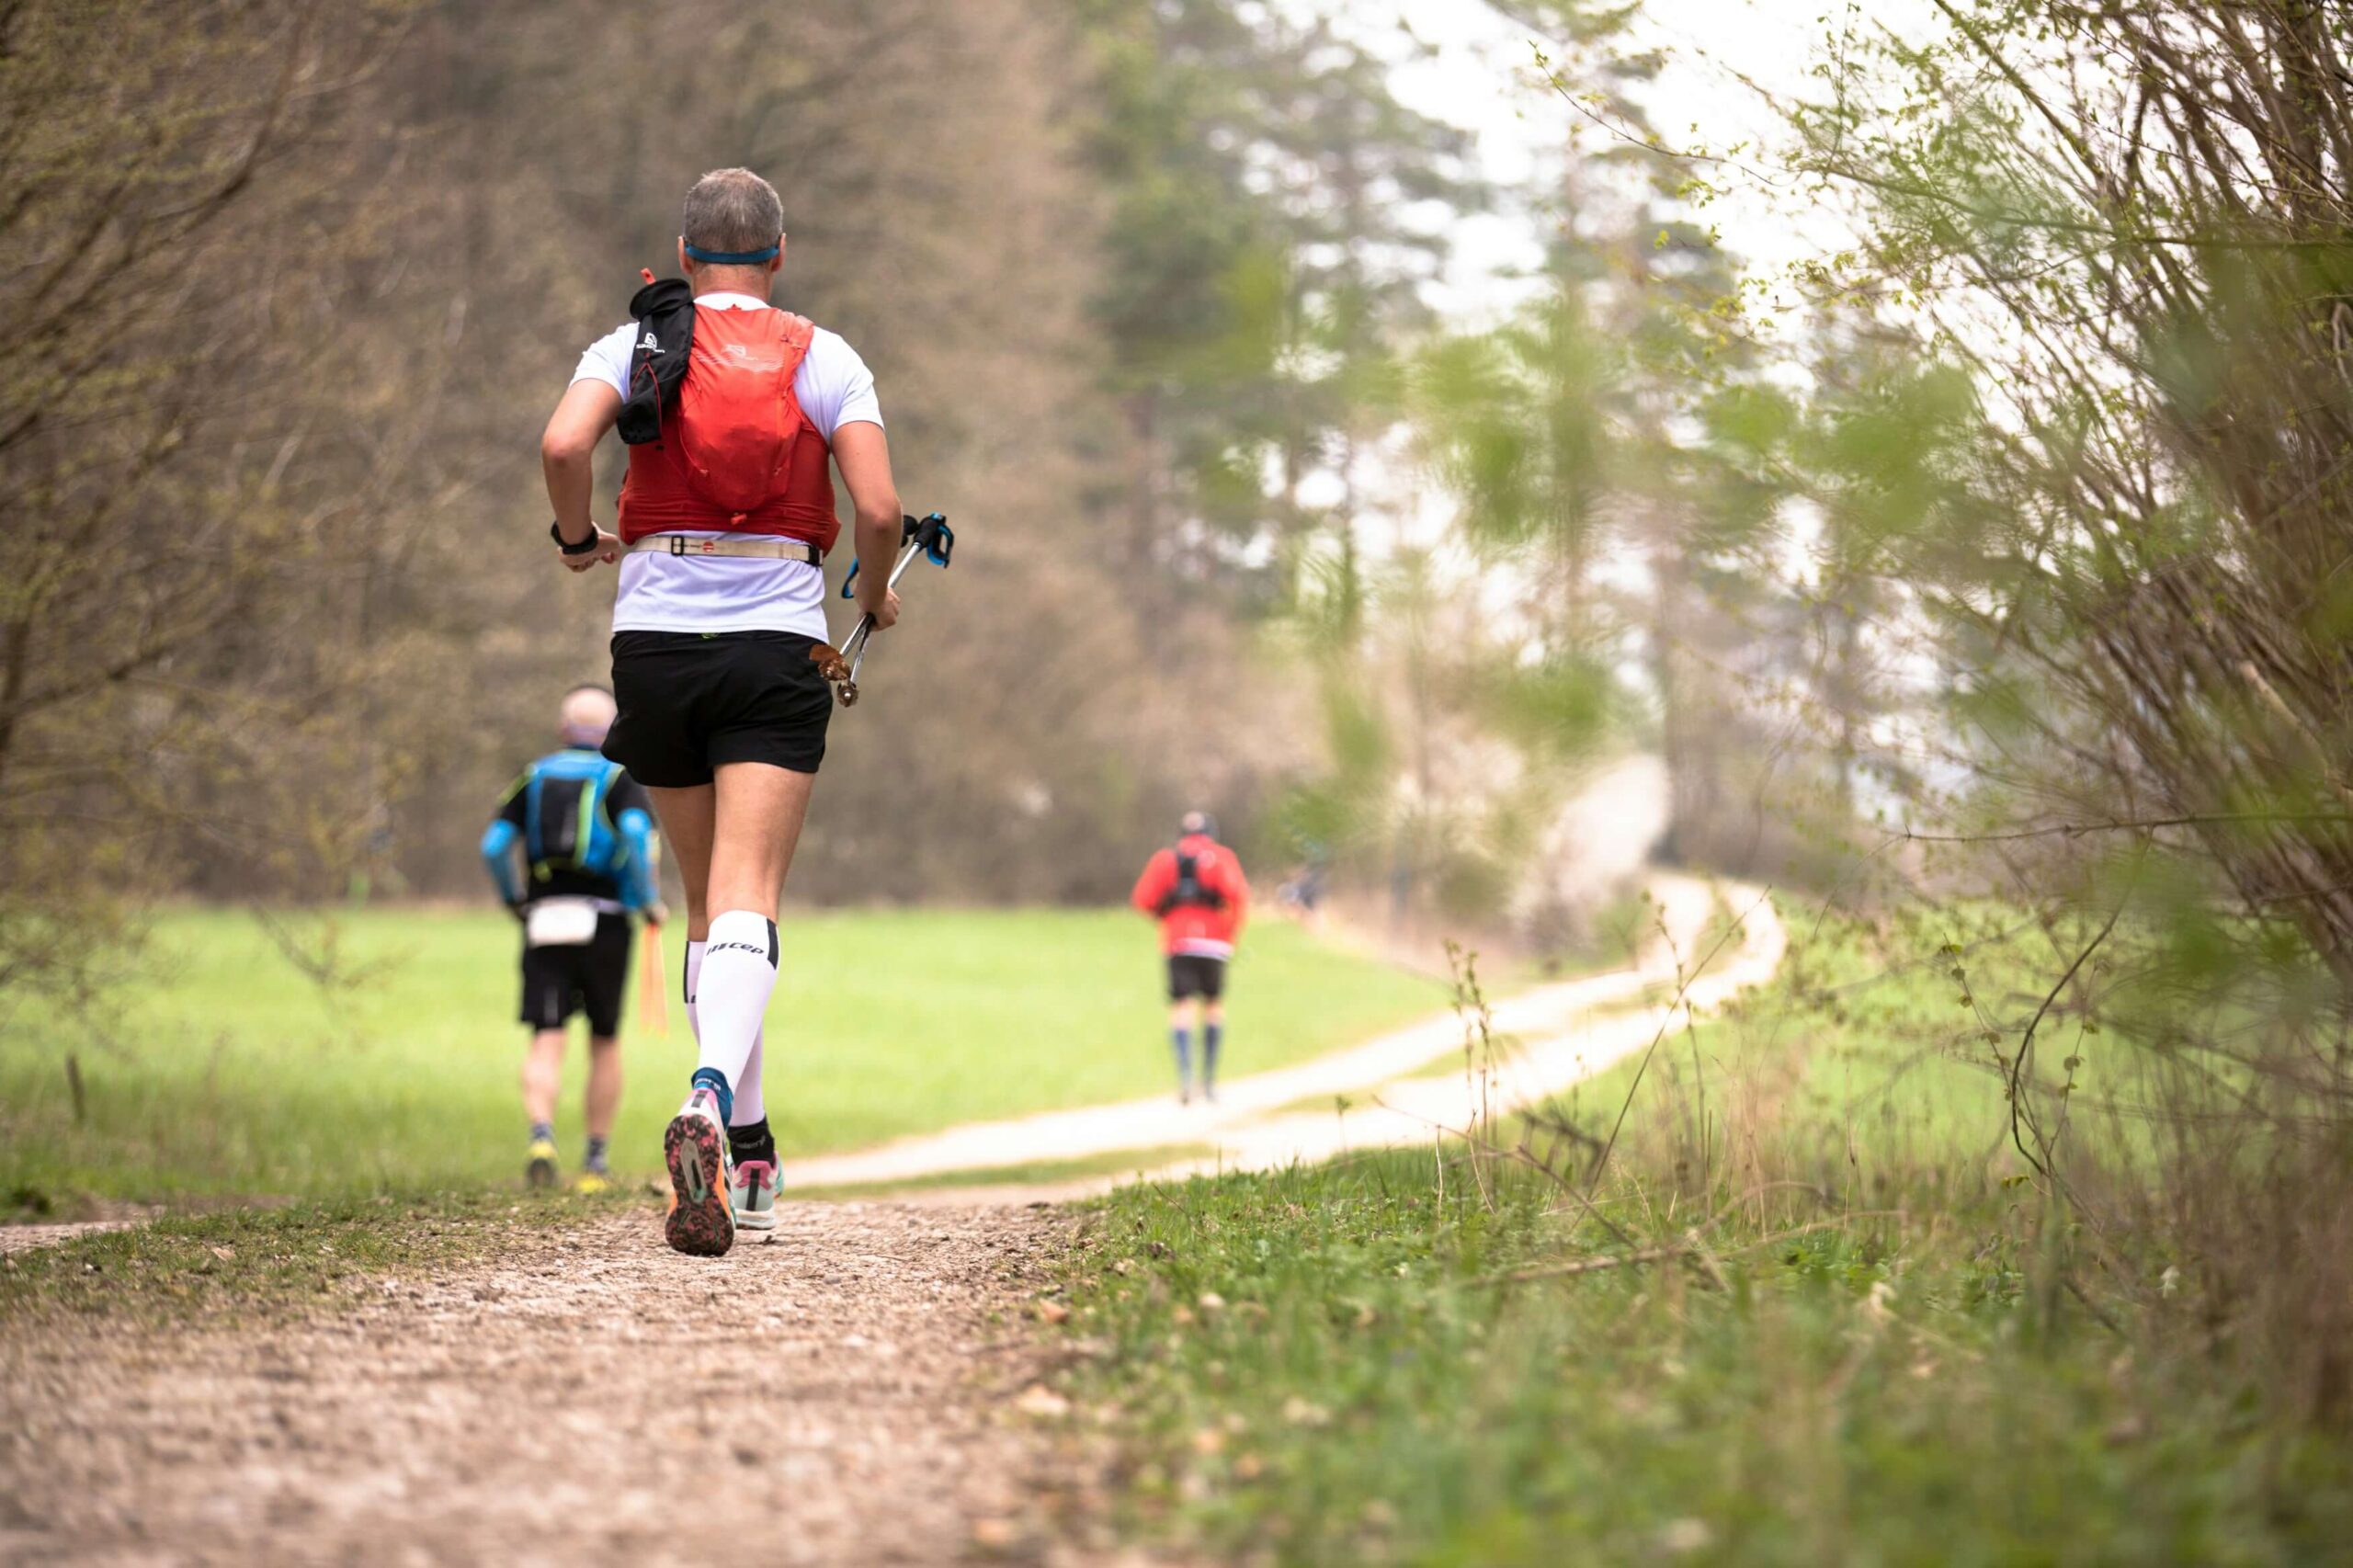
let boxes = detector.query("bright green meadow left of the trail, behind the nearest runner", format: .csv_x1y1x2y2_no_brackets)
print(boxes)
0,911,1447,1212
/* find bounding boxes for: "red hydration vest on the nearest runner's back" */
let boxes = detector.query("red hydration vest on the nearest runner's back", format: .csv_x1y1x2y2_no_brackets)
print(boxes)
621,306,840,553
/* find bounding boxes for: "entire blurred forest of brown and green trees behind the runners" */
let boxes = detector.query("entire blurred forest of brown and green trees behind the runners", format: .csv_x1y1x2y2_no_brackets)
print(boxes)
14,0,2353,1092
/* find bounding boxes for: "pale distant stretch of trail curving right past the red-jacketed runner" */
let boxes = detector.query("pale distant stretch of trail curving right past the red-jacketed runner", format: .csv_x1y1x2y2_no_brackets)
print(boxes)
783,876,1789,1199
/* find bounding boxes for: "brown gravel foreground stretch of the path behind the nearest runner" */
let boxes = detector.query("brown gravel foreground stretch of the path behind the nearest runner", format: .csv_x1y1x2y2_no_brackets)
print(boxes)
0,1203,1085,1565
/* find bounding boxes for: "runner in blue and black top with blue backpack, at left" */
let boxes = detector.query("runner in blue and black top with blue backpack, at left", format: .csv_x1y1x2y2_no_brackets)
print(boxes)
483,685,661,1191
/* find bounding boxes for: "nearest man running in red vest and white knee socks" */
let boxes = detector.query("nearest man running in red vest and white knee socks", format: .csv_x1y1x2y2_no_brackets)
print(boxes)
539,169,901,1255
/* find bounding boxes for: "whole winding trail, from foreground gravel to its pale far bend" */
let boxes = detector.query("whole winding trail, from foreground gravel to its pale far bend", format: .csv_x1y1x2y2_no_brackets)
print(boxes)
0,881,1786,1568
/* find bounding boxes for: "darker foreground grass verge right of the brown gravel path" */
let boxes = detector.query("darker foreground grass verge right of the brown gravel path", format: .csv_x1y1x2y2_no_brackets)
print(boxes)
1063,1153,2353,1563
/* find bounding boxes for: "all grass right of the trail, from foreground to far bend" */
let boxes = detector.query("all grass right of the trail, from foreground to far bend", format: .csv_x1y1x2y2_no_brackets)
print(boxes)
1056,909,2353,1568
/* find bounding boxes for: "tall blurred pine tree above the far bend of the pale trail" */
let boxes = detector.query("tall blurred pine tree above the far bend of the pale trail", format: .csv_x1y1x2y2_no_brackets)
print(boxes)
1421,0,1783,857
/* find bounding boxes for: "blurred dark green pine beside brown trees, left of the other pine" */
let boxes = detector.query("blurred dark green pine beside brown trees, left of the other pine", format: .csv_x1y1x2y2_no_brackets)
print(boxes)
1080,0,1480,619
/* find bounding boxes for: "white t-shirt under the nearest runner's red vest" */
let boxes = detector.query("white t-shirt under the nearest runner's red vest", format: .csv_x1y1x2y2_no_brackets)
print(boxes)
572,294,882,642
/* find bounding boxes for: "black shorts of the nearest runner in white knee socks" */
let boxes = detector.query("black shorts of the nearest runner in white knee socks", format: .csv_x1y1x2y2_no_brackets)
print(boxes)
605,631,833,789
